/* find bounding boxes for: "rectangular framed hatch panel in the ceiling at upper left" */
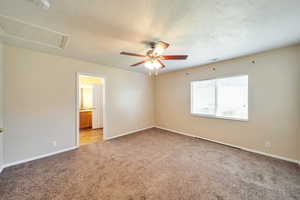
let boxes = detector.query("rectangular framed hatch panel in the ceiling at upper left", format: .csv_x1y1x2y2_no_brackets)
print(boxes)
0,15,69,49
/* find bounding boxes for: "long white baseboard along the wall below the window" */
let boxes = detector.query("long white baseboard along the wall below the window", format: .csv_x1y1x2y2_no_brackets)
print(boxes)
155,126,300,165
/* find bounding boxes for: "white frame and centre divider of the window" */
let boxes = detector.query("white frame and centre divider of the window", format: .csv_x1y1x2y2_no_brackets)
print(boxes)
190,74,249,122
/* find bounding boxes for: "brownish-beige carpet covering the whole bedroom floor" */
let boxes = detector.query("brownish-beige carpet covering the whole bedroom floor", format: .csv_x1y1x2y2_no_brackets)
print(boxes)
0,129,300,200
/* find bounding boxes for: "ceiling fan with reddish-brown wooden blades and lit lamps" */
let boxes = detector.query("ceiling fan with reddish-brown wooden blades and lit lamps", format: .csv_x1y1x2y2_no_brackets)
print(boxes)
120,41,188,73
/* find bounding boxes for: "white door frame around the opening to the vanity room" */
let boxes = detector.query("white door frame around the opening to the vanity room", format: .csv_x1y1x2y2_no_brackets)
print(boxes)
75,72,107,147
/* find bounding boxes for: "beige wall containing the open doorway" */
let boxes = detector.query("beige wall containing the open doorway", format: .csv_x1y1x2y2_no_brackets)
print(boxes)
4,46,154,164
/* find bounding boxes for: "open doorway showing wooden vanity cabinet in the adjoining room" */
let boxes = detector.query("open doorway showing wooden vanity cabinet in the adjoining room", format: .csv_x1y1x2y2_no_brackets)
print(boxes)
76,73,105,146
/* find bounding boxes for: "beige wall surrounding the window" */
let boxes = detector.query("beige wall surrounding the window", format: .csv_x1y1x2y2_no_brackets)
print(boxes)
155,45,300,160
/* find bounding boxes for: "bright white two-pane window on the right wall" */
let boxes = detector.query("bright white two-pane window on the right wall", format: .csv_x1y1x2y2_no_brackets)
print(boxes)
191,75,248,120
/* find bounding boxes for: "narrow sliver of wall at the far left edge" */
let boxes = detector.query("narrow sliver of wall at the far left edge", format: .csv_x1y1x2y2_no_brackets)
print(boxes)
0,40,4,170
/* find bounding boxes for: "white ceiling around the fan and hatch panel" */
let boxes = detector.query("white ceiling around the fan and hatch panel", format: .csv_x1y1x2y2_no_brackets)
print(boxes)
0,0,300,72
